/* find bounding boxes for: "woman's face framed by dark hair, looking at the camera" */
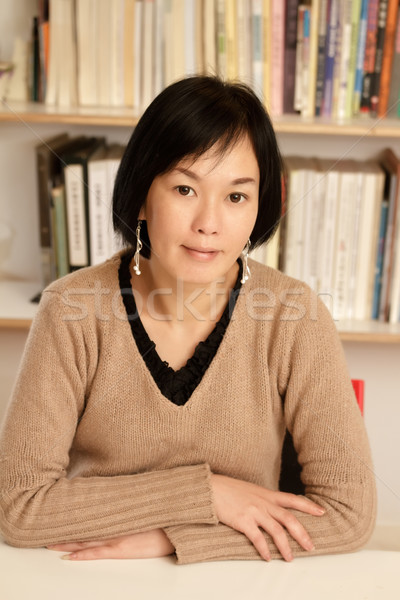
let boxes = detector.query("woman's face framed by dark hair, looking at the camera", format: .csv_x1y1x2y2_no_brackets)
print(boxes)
139,136,260,284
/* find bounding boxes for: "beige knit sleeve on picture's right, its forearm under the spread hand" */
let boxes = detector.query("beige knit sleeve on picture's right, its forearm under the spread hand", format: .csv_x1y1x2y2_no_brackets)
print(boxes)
165,290,376,564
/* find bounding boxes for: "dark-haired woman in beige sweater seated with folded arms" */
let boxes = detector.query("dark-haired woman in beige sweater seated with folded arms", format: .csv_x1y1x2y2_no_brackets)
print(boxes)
0,77,375,563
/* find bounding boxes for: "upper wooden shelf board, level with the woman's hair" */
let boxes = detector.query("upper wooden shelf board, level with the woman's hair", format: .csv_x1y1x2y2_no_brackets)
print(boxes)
0,100,400,138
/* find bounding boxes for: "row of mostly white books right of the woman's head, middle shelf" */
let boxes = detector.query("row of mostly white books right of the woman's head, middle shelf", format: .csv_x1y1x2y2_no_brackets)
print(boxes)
261,148,400,323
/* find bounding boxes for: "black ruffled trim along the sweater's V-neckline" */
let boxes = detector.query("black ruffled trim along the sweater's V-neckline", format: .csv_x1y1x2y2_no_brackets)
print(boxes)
118,252,242,406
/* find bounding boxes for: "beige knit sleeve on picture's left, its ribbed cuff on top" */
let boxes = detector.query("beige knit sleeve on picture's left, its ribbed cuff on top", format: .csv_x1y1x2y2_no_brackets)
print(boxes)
0,292,217,547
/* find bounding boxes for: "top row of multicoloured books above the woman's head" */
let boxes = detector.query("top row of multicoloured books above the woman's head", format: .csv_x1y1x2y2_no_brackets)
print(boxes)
3,0,400,119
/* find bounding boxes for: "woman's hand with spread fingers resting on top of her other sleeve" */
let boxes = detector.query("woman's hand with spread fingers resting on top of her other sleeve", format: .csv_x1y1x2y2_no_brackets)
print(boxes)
211,474,325,561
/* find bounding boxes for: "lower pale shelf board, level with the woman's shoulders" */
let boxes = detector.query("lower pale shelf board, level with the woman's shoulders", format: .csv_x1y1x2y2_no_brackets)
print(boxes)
0,281,400,344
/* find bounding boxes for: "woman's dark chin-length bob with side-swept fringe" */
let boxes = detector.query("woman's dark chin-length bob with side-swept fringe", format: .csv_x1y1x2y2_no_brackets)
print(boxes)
113,76,282,258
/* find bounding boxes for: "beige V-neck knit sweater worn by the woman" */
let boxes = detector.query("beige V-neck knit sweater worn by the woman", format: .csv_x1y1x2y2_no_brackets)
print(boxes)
0,255,376,563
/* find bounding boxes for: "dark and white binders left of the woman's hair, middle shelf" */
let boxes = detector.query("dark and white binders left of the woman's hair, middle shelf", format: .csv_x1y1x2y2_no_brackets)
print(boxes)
36,133,124,287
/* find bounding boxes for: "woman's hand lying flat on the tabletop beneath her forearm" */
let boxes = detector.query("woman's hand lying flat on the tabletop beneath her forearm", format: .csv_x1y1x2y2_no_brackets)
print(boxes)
47,529,175,560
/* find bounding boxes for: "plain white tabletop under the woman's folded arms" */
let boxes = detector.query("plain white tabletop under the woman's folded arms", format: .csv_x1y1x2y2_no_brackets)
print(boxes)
0,542,400,600
